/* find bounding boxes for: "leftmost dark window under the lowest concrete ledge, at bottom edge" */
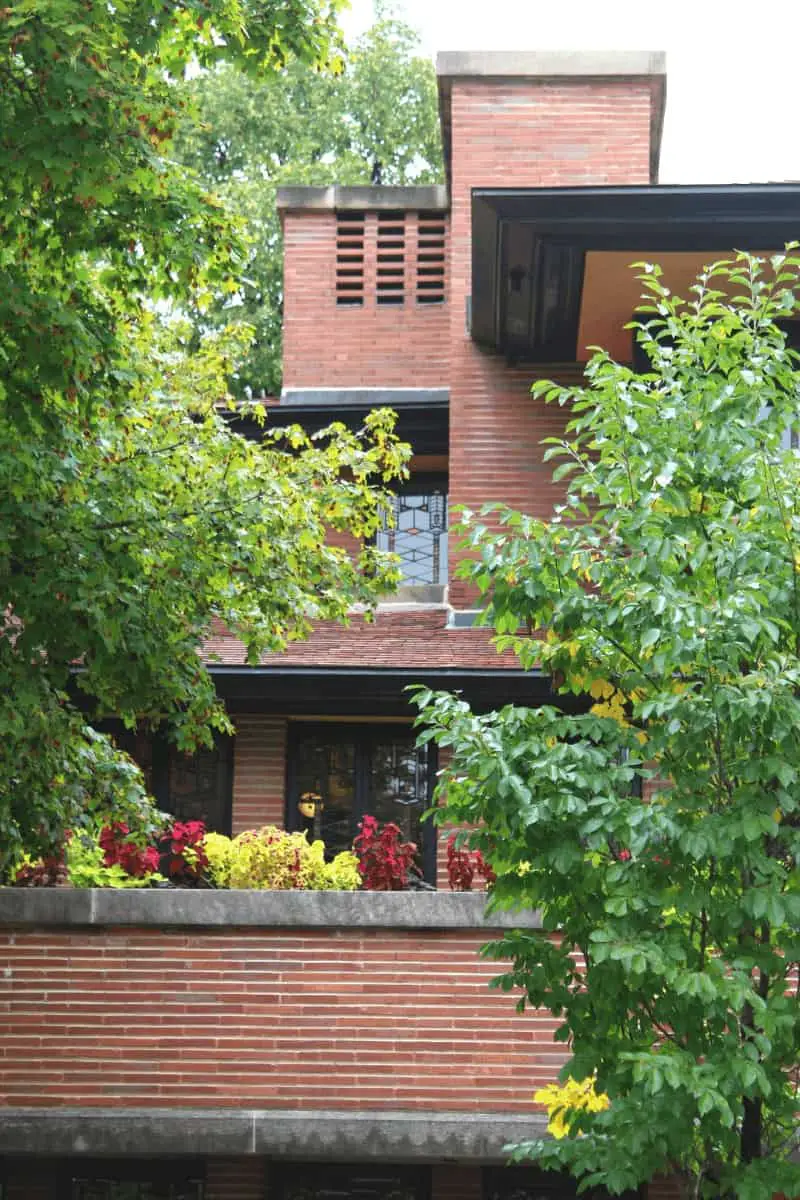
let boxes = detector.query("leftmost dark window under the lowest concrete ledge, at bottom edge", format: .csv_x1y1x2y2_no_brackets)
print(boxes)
59,1159,205,1200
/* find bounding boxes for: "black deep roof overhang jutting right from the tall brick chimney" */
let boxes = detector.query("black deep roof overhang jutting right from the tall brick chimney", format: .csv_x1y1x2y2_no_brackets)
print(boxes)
471,184,800,362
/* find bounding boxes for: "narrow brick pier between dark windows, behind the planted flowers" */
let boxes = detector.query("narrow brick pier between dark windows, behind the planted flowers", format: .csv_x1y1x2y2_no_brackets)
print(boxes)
233,713,287,835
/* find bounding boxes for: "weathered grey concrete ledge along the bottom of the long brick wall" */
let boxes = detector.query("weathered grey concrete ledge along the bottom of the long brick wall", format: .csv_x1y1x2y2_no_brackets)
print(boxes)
0,1108,546,1163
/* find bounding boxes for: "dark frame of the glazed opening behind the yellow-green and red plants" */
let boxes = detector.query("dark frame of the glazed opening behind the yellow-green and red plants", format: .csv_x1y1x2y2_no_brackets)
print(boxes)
285,720,439,884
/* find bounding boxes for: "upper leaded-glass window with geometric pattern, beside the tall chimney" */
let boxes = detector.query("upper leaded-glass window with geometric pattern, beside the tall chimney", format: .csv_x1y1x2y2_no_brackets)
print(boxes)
378,476,447,586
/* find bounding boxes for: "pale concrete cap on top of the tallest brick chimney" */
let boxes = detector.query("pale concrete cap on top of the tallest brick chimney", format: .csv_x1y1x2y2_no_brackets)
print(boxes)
437,50,667,79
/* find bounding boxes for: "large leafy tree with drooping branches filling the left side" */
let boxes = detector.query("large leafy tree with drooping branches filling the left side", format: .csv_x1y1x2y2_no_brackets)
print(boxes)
0,0,405,874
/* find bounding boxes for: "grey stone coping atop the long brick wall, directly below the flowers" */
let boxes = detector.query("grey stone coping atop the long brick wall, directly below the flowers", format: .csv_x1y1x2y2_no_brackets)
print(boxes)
0,888,541,931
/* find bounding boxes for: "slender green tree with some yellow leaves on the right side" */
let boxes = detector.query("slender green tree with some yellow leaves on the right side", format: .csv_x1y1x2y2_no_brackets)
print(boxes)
419,254,800,1200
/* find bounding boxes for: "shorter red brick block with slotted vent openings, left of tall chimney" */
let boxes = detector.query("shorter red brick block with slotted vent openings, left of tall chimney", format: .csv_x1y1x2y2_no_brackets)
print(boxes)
283,210,450,388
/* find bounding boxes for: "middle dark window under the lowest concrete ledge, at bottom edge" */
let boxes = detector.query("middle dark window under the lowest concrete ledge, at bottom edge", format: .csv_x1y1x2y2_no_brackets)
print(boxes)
270,1163,431,1200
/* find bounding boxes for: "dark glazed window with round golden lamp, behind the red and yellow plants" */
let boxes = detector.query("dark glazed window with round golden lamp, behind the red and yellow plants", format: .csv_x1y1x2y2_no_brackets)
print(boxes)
287,721,435,882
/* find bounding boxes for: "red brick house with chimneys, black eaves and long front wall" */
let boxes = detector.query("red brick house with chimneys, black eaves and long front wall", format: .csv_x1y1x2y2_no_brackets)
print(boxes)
0,46,800,1200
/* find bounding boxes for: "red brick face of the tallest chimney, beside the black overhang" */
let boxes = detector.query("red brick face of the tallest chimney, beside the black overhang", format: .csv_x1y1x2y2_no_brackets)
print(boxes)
450,79,651,607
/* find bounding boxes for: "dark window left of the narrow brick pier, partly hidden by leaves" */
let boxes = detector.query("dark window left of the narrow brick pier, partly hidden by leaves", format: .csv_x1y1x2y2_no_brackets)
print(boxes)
110,726,233,834
